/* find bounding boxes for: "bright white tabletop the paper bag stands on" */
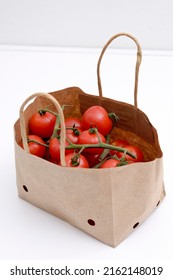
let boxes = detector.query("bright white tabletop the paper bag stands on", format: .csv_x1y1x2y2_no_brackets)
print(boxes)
0,46,173,260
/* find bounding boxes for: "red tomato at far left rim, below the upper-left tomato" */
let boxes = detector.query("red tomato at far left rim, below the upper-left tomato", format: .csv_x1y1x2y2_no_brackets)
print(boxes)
28,135,46,158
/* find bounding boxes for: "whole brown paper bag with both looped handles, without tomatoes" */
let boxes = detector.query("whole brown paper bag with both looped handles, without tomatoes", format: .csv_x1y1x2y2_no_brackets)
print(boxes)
14,33,165,247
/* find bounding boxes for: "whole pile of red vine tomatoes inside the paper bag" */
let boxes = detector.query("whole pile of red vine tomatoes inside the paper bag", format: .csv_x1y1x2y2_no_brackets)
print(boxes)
23,105,144,168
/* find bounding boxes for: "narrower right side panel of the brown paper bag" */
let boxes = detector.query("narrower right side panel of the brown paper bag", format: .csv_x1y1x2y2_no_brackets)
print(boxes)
112,158,165,245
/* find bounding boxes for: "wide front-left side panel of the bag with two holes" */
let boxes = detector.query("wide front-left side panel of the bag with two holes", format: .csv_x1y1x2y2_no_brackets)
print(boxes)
15,143,114,246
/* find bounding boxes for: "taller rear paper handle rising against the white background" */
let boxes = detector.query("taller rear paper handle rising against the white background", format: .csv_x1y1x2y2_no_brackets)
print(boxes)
97,33,142,107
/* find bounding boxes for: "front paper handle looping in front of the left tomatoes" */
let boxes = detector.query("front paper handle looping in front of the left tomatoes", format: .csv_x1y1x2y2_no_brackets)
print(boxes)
19,92,66,166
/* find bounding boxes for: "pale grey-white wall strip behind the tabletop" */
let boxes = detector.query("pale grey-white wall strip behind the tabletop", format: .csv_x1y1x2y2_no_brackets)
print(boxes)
0,0,173,50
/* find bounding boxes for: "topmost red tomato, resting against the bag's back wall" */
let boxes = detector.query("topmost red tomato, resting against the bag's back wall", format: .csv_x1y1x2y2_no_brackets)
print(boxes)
82,105,113,136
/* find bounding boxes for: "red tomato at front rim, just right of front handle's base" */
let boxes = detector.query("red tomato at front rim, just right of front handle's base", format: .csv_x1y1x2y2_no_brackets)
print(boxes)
62,153,89,168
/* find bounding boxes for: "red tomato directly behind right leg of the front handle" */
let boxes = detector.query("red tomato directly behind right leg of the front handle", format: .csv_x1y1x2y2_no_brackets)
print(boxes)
49,138,73,163
